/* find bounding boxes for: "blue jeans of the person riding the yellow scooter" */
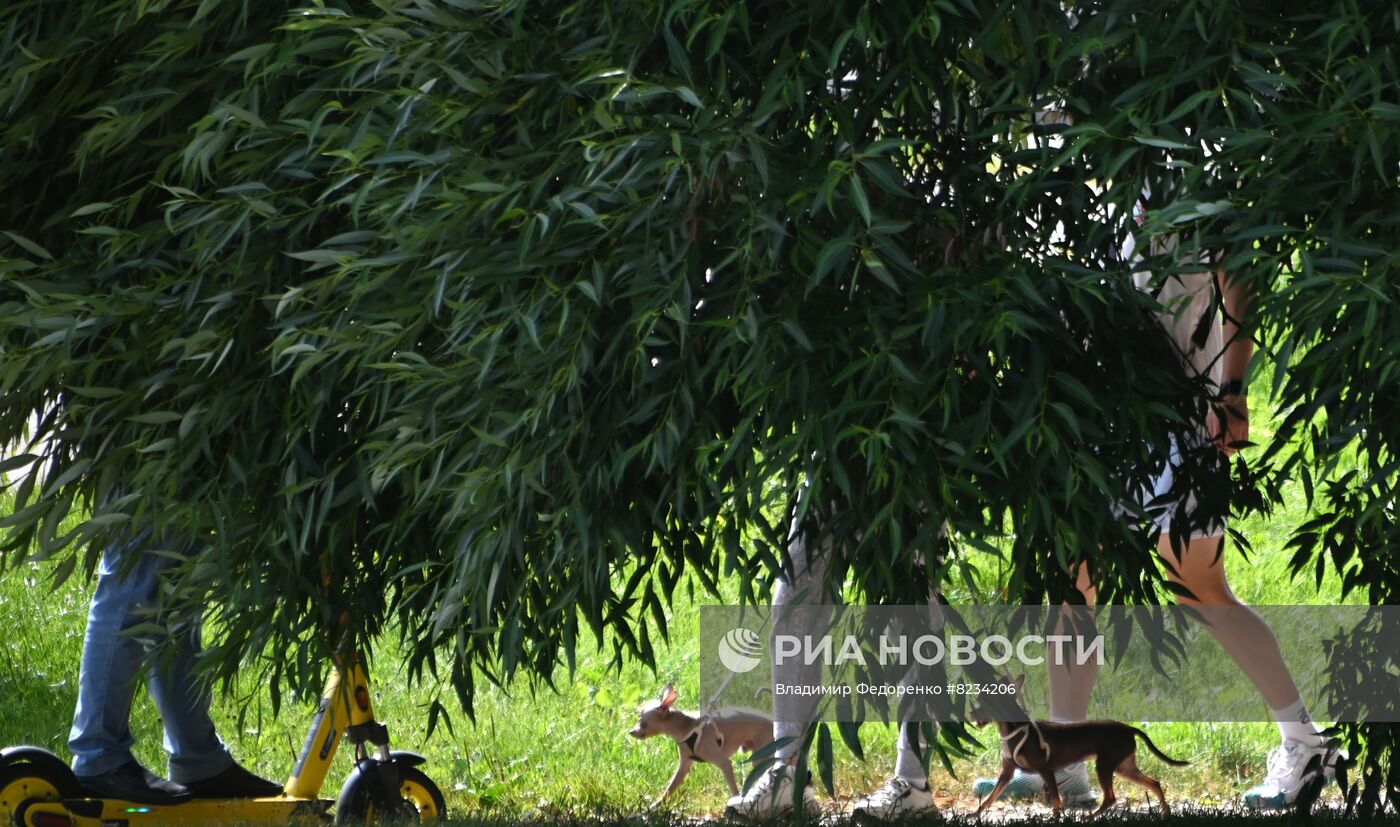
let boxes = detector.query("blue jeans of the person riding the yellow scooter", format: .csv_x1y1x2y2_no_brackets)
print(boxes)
69,535,234,784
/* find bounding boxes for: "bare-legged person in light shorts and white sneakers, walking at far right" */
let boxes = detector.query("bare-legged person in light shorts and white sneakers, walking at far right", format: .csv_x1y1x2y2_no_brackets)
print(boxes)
973,196,1329,809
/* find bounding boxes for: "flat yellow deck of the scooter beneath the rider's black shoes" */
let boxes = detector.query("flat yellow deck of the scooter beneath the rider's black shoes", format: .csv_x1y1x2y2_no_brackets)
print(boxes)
22,796,335,827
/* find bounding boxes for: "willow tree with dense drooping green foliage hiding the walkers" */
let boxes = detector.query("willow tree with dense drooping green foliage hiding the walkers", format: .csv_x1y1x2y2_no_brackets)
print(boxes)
0,0,1400,817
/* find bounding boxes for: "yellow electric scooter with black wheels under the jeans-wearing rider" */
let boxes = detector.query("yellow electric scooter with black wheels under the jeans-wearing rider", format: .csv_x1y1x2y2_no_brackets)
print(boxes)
0,656,447,827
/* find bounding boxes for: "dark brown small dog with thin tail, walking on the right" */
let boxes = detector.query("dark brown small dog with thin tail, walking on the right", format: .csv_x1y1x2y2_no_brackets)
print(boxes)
972,674,1189,817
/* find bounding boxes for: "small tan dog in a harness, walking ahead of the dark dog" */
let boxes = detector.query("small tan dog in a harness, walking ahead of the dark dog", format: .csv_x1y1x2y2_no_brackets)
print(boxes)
629,683,773,806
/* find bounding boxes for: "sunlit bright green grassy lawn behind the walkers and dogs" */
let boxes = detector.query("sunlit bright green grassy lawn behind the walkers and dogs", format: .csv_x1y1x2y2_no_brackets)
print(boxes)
0,386,1366,823
